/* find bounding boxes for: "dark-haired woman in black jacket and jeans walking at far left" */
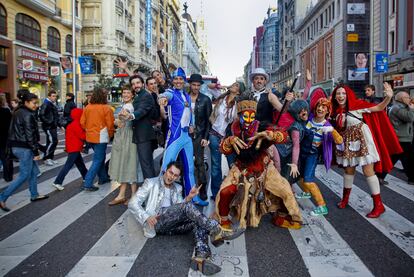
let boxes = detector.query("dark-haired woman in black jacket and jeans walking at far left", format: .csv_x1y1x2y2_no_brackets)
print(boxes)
0,90,49,212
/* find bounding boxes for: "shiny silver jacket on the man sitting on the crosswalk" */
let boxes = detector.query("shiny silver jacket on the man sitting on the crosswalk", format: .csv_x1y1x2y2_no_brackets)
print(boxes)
128,175,184,235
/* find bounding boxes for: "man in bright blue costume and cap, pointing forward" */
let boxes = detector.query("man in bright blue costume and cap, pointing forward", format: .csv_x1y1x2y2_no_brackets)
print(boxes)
159,67,208,206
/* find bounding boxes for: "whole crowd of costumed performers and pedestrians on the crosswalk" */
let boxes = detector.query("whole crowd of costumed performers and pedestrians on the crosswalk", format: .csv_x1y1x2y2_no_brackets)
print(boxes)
0,53,414,275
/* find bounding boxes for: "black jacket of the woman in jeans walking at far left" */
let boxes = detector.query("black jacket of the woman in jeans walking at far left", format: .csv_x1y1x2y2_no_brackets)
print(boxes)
9,106,40,156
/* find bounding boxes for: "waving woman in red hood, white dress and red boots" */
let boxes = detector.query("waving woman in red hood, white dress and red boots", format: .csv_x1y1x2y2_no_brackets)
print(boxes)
331,83,393,218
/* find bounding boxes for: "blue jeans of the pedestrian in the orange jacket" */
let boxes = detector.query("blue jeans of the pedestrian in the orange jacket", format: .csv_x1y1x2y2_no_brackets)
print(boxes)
84,143,109,188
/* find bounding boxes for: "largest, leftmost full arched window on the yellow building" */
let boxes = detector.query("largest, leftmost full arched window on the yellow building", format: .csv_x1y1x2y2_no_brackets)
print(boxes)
16,13,41,47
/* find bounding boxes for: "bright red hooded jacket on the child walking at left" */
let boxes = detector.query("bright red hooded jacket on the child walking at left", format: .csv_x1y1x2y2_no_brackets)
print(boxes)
66,108,86,153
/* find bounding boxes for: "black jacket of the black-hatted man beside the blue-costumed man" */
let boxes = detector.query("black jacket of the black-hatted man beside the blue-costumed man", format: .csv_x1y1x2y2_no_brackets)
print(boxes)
194,93,213,140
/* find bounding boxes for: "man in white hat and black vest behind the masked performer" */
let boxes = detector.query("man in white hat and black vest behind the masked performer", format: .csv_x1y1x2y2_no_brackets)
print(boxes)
250,67,294,125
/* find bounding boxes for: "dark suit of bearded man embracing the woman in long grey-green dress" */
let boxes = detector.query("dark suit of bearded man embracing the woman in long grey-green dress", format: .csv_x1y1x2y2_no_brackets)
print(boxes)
132,89,156,179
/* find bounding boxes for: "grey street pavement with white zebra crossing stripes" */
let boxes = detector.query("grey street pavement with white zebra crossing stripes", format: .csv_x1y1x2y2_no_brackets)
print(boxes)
0,130,414,277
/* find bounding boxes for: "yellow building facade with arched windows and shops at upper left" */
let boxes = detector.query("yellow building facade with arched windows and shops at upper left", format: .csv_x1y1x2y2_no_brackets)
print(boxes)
0,0,81,102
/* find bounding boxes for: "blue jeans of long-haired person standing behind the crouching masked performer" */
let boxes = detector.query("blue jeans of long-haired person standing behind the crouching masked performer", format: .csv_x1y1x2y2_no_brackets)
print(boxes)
209,134,236,199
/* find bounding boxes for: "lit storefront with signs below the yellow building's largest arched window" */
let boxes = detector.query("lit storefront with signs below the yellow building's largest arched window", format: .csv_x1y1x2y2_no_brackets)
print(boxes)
16,46,49,100
